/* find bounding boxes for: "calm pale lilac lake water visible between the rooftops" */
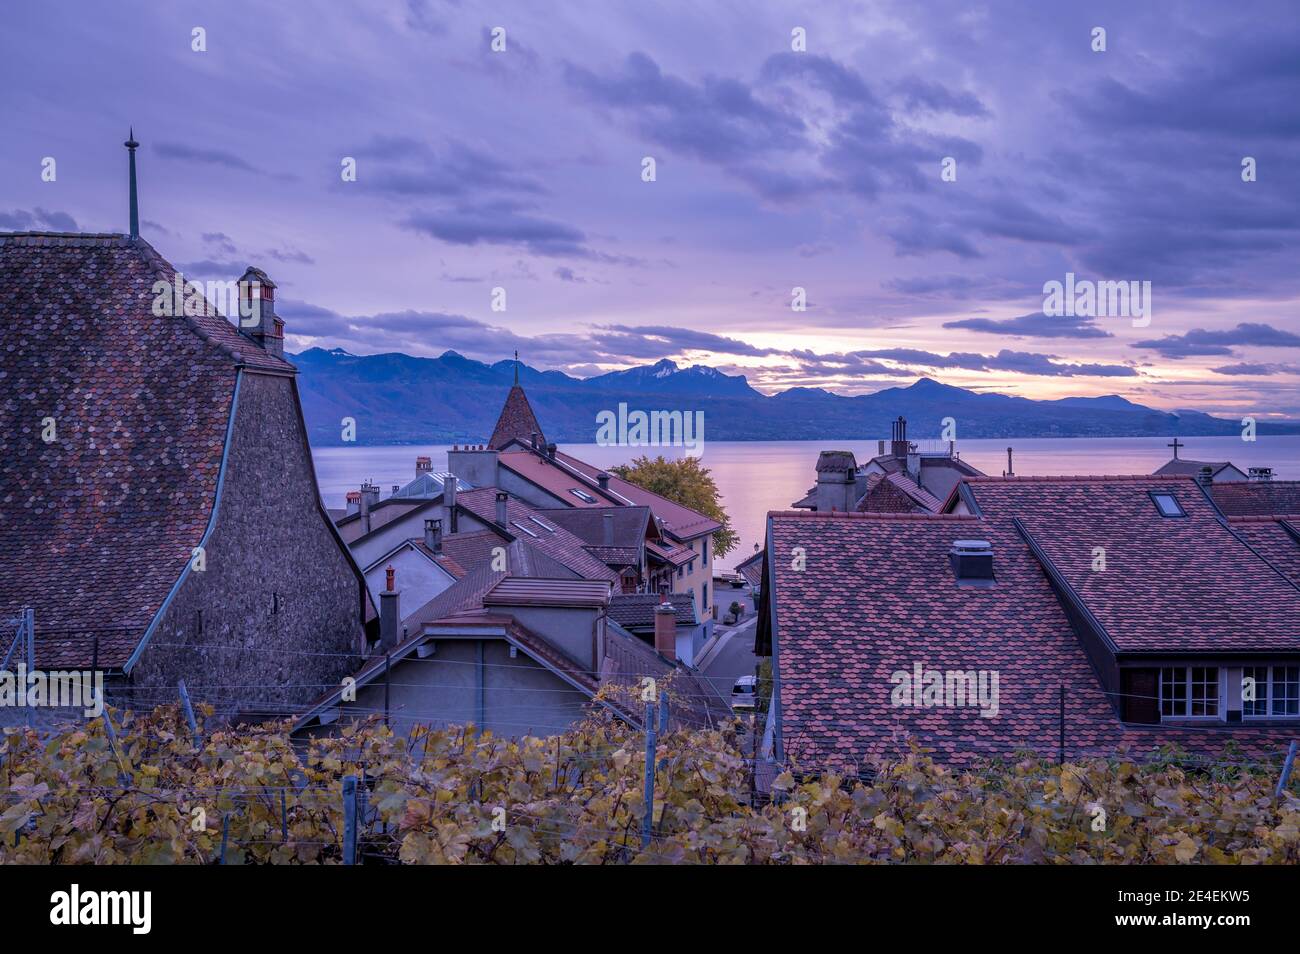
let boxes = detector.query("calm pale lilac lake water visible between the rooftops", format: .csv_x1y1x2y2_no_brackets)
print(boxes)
313,435,1300,569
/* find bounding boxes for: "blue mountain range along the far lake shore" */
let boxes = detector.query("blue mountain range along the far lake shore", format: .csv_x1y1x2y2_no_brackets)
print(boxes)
290,348,1300,446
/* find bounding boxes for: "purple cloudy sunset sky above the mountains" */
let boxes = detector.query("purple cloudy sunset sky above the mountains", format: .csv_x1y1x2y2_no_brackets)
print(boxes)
0,0,1300,419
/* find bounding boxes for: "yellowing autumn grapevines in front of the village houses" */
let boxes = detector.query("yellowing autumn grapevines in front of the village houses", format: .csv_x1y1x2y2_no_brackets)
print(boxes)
0,707,1300,864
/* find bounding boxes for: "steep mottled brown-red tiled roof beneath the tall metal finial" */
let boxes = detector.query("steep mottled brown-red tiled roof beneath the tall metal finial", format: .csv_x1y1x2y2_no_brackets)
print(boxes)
0,233,294,667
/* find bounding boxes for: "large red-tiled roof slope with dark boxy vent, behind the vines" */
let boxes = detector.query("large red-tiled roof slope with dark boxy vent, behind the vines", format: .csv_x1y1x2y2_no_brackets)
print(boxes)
768,512,1294,771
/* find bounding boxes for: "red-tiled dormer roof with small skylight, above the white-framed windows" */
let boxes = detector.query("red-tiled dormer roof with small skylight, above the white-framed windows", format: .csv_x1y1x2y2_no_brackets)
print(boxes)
967,476,1300,652
